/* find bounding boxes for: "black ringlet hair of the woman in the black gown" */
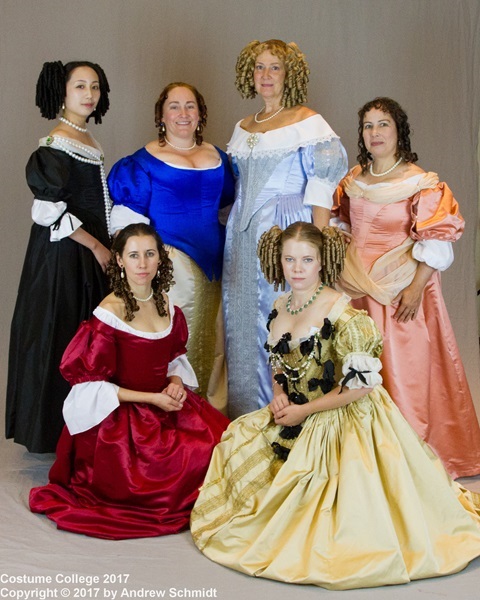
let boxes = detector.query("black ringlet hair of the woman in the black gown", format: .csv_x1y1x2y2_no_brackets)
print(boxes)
35,60,110,123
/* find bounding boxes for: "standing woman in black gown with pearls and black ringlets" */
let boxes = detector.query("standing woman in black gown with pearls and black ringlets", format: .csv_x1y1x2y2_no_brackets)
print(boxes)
6,61,110,452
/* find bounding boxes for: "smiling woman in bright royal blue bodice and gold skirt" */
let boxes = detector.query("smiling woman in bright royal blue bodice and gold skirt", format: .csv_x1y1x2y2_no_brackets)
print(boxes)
108,82,234,409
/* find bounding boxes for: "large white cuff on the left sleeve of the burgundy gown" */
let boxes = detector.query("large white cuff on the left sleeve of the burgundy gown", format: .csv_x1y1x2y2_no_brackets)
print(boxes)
63,381,120,435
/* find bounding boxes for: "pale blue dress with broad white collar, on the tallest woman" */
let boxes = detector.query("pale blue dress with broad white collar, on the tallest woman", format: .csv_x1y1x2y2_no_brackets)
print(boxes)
222,114,347,418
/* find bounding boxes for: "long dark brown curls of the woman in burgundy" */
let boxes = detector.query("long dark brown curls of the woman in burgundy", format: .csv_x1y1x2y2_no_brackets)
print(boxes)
107,223,175,321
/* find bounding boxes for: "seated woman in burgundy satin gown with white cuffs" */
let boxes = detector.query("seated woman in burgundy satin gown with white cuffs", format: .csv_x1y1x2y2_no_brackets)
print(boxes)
30,224,228,539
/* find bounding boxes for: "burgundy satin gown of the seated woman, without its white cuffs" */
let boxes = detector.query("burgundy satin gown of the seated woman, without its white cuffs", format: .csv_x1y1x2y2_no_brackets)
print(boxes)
30,307,228,539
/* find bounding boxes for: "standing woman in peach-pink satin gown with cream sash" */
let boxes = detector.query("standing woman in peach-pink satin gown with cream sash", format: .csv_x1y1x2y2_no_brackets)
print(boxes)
337,98,480,477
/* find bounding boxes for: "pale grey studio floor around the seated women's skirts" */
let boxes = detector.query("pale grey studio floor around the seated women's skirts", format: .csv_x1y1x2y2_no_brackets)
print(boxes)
0,440,480,600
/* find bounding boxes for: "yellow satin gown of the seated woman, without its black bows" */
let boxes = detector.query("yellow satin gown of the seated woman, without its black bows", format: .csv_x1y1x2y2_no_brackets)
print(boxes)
191,297,480,590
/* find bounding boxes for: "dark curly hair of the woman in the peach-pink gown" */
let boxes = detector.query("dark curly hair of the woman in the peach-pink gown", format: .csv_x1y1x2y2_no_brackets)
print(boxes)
357,97,418,173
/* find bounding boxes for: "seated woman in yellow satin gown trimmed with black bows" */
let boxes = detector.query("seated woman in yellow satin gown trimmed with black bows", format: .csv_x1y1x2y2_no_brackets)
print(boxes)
191,222,480,589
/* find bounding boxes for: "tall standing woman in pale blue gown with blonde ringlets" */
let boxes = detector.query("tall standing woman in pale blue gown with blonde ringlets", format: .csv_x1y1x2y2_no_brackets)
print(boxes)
223,40,347,417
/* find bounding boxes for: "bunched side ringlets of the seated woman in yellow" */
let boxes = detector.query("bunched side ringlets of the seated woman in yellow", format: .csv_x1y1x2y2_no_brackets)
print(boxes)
257,221,345,291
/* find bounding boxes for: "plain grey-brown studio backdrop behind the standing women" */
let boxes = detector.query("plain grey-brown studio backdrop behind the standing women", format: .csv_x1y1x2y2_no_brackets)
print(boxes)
0,0,480,412
